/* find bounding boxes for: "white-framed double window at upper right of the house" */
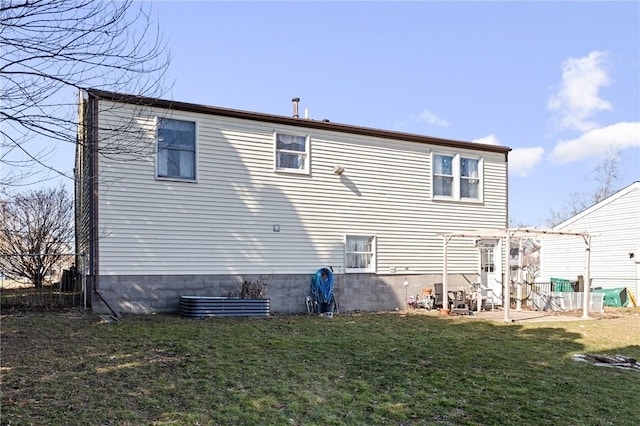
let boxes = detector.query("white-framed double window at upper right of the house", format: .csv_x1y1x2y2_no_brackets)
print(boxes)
432,154,482,201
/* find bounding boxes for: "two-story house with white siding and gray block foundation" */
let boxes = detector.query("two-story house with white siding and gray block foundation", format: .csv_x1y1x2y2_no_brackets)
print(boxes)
75,90,510,313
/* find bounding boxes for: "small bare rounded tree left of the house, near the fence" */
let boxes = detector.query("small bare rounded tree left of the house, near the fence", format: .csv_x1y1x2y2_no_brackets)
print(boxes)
0,186,74,287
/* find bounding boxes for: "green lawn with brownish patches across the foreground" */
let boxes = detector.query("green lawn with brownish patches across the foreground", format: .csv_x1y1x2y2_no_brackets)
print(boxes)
1,309,640,425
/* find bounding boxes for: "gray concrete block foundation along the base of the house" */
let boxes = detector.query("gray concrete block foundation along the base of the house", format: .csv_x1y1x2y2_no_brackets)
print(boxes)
90,274,473,314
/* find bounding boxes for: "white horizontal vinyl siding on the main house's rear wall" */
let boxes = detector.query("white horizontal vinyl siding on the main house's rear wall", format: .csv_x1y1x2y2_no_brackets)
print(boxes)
99,101,507,275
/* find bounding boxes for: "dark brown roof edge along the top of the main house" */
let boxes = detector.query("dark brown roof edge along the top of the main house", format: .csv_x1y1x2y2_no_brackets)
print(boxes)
86,89,511,155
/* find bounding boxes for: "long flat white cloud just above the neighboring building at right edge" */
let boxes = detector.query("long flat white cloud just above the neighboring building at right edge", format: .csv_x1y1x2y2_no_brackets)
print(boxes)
551,122,640,163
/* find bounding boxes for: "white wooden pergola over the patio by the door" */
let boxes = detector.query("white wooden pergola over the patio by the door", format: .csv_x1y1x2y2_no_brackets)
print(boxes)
438,228,592,322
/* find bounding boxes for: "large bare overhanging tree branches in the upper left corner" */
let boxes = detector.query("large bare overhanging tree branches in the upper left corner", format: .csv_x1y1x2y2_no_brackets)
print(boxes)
0,0,169,187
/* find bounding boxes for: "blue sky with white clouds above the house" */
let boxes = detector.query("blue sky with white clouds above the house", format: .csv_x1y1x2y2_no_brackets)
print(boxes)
6,1,640,226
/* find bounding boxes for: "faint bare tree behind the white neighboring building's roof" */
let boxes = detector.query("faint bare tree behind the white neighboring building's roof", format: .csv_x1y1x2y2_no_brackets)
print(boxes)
547,146,620,227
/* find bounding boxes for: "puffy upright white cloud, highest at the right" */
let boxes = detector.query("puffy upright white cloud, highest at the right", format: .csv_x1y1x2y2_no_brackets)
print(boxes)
548,51,613,132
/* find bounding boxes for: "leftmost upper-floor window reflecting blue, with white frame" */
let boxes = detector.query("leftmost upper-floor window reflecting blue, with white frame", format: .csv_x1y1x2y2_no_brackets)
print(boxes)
156,118,196,180
